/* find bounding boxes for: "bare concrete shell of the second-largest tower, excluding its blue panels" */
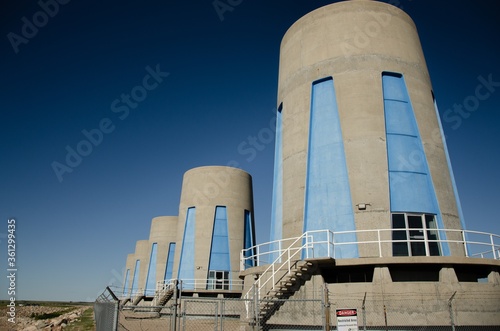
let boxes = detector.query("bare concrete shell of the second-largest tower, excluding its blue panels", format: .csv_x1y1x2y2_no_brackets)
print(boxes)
173,166,253,290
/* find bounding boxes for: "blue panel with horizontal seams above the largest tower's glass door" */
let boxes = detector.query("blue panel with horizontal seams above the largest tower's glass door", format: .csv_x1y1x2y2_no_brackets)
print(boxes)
382,72,449,255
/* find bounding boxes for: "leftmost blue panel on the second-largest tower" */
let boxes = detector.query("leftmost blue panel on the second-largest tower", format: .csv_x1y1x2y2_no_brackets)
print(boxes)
177,207,196,290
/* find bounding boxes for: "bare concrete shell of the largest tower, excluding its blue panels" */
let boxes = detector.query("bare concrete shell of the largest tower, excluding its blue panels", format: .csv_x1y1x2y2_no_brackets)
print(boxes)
278,0,463,256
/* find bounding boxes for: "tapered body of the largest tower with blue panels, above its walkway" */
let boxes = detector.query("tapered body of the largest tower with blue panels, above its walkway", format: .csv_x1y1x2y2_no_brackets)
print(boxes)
271,0,464,258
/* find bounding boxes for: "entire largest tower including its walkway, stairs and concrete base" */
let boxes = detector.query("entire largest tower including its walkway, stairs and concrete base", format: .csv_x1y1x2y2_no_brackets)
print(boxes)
241,0,500,329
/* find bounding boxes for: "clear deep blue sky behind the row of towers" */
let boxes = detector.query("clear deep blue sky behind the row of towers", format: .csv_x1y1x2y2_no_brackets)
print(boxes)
0,0,500,301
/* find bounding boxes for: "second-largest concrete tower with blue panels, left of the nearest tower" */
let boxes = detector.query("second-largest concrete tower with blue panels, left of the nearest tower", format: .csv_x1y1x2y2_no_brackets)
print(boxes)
174,166,255,290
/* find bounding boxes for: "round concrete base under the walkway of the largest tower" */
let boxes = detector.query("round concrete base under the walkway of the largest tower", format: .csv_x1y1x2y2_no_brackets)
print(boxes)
242,257,500,330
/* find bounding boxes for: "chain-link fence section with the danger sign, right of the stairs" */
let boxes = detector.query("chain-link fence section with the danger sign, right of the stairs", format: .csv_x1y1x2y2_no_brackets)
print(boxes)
327,292,500,331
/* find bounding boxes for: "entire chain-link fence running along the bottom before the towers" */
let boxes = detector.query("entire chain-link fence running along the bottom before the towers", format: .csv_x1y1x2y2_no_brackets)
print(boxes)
95,284,500,331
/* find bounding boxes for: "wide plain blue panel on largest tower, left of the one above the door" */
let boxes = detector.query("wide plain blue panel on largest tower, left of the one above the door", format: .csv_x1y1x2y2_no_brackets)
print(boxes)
304,77,359,258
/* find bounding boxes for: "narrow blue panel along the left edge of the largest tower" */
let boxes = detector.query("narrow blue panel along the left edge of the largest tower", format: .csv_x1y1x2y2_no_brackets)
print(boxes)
267,105,283,263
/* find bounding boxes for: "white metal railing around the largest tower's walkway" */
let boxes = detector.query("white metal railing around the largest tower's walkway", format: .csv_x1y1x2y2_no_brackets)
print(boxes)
240,228,500,270
